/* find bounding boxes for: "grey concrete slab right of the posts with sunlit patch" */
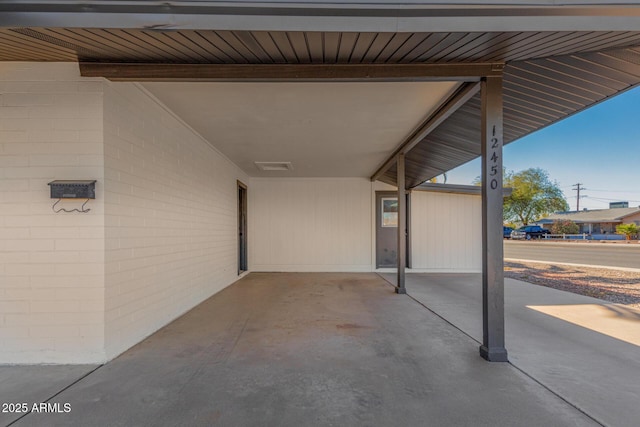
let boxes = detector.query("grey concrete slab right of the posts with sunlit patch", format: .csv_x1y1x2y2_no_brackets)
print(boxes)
384,274,640,427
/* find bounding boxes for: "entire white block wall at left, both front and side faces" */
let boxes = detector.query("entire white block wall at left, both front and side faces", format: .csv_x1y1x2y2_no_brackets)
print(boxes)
0,63,251,363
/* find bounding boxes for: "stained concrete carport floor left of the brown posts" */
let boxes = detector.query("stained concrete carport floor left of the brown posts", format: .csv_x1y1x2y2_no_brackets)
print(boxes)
0,273,597,427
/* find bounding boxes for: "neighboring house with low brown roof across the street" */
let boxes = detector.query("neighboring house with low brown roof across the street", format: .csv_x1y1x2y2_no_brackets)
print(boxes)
536,207,640,234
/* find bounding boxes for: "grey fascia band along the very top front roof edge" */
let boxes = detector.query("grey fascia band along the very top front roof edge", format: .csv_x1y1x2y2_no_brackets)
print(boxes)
0,0,640,32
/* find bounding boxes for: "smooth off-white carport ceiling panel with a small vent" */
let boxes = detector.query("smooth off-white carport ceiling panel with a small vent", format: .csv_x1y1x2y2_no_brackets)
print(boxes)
144,82,457,177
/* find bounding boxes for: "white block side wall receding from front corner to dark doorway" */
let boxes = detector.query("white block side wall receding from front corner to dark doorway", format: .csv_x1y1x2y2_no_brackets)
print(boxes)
105,83,251,357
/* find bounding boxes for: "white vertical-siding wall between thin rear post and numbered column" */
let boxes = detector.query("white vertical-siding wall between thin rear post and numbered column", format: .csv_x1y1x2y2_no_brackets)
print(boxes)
411,191,482,272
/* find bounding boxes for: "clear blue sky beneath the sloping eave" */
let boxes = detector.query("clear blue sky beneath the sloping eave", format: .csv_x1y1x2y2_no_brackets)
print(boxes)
447,87,640,210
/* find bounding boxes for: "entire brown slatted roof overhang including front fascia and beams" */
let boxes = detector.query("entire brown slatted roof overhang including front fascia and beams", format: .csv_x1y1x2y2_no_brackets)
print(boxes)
0,0,640,188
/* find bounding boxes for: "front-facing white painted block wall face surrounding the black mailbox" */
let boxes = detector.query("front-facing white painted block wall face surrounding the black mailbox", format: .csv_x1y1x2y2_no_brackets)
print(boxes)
0,62,105,363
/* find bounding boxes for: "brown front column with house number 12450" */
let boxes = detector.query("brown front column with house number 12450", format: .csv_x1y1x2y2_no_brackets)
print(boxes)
480,77,508,362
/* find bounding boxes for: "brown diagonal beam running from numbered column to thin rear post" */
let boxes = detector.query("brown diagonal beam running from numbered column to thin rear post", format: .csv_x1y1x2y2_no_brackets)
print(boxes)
371,82,480,181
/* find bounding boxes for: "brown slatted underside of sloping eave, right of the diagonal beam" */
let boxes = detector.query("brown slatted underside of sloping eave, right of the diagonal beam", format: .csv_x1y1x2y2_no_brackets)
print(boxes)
378,48,640,188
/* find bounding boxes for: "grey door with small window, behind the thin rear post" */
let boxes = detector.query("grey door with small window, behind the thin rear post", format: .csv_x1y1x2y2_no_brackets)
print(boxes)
376,191,411,268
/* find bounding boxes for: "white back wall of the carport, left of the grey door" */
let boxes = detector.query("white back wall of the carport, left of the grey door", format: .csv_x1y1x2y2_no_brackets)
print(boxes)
248,178,372,271
